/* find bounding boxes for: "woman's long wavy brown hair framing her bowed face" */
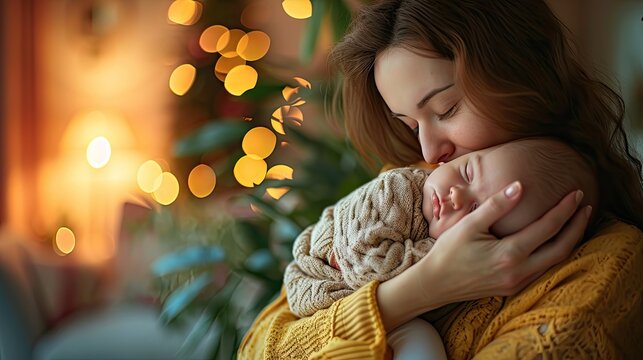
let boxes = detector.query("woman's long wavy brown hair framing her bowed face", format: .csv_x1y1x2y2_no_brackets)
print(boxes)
331,0,643,228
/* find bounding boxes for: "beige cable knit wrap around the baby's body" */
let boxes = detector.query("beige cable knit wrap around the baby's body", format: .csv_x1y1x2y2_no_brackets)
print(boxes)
284,168,434,316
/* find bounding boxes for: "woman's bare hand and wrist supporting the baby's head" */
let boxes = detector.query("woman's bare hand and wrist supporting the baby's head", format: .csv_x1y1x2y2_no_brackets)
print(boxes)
378,182,591,330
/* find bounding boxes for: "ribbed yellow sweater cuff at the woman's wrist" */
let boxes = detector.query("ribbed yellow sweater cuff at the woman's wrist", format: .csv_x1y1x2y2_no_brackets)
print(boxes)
311,281,390,359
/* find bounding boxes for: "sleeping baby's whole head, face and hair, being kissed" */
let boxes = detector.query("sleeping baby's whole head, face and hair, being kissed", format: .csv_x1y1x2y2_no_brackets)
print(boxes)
422,138,598,238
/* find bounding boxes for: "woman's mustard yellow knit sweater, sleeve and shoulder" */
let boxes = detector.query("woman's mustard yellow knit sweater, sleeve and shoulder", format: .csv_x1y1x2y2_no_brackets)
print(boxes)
238,223,643,359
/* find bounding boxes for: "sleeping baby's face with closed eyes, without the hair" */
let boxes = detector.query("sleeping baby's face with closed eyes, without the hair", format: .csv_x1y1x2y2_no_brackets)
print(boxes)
422,145,542,239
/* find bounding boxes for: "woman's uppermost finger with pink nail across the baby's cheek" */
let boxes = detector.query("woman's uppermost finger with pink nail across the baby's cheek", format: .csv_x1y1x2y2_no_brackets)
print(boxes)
462,181,522,231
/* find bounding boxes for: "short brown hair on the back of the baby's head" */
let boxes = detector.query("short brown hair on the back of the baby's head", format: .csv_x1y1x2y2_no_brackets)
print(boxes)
505,138,601,235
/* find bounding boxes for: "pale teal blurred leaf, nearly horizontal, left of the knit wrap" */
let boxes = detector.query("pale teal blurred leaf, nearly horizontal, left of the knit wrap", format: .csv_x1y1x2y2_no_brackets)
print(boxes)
152,246,225,276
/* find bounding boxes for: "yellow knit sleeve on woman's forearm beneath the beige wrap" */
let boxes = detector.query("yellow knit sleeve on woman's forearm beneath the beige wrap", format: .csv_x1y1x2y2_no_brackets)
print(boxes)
238,282,390,359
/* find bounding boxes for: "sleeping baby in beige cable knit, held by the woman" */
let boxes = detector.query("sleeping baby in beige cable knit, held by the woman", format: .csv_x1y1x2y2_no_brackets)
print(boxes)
284,138,598,359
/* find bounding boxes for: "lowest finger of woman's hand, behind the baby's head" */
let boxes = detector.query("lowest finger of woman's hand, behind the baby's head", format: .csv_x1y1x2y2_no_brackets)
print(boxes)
522,206,592,274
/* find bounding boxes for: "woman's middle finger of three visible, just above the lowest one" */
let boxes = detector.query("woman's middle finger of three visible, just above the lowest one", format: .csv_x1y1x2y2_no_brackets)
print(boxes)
503,190,587,257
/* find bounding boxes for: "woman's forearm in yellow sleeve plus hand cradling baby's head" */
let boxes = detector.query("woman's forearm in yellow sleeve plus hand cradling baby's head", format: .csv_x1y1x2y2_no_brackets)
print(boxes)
239,181,587,359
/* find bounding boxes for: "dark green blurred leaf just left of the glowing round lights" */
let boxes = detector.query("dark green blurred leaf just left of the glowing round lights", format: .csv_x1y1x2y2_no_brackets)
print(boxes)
174,119,252,157
